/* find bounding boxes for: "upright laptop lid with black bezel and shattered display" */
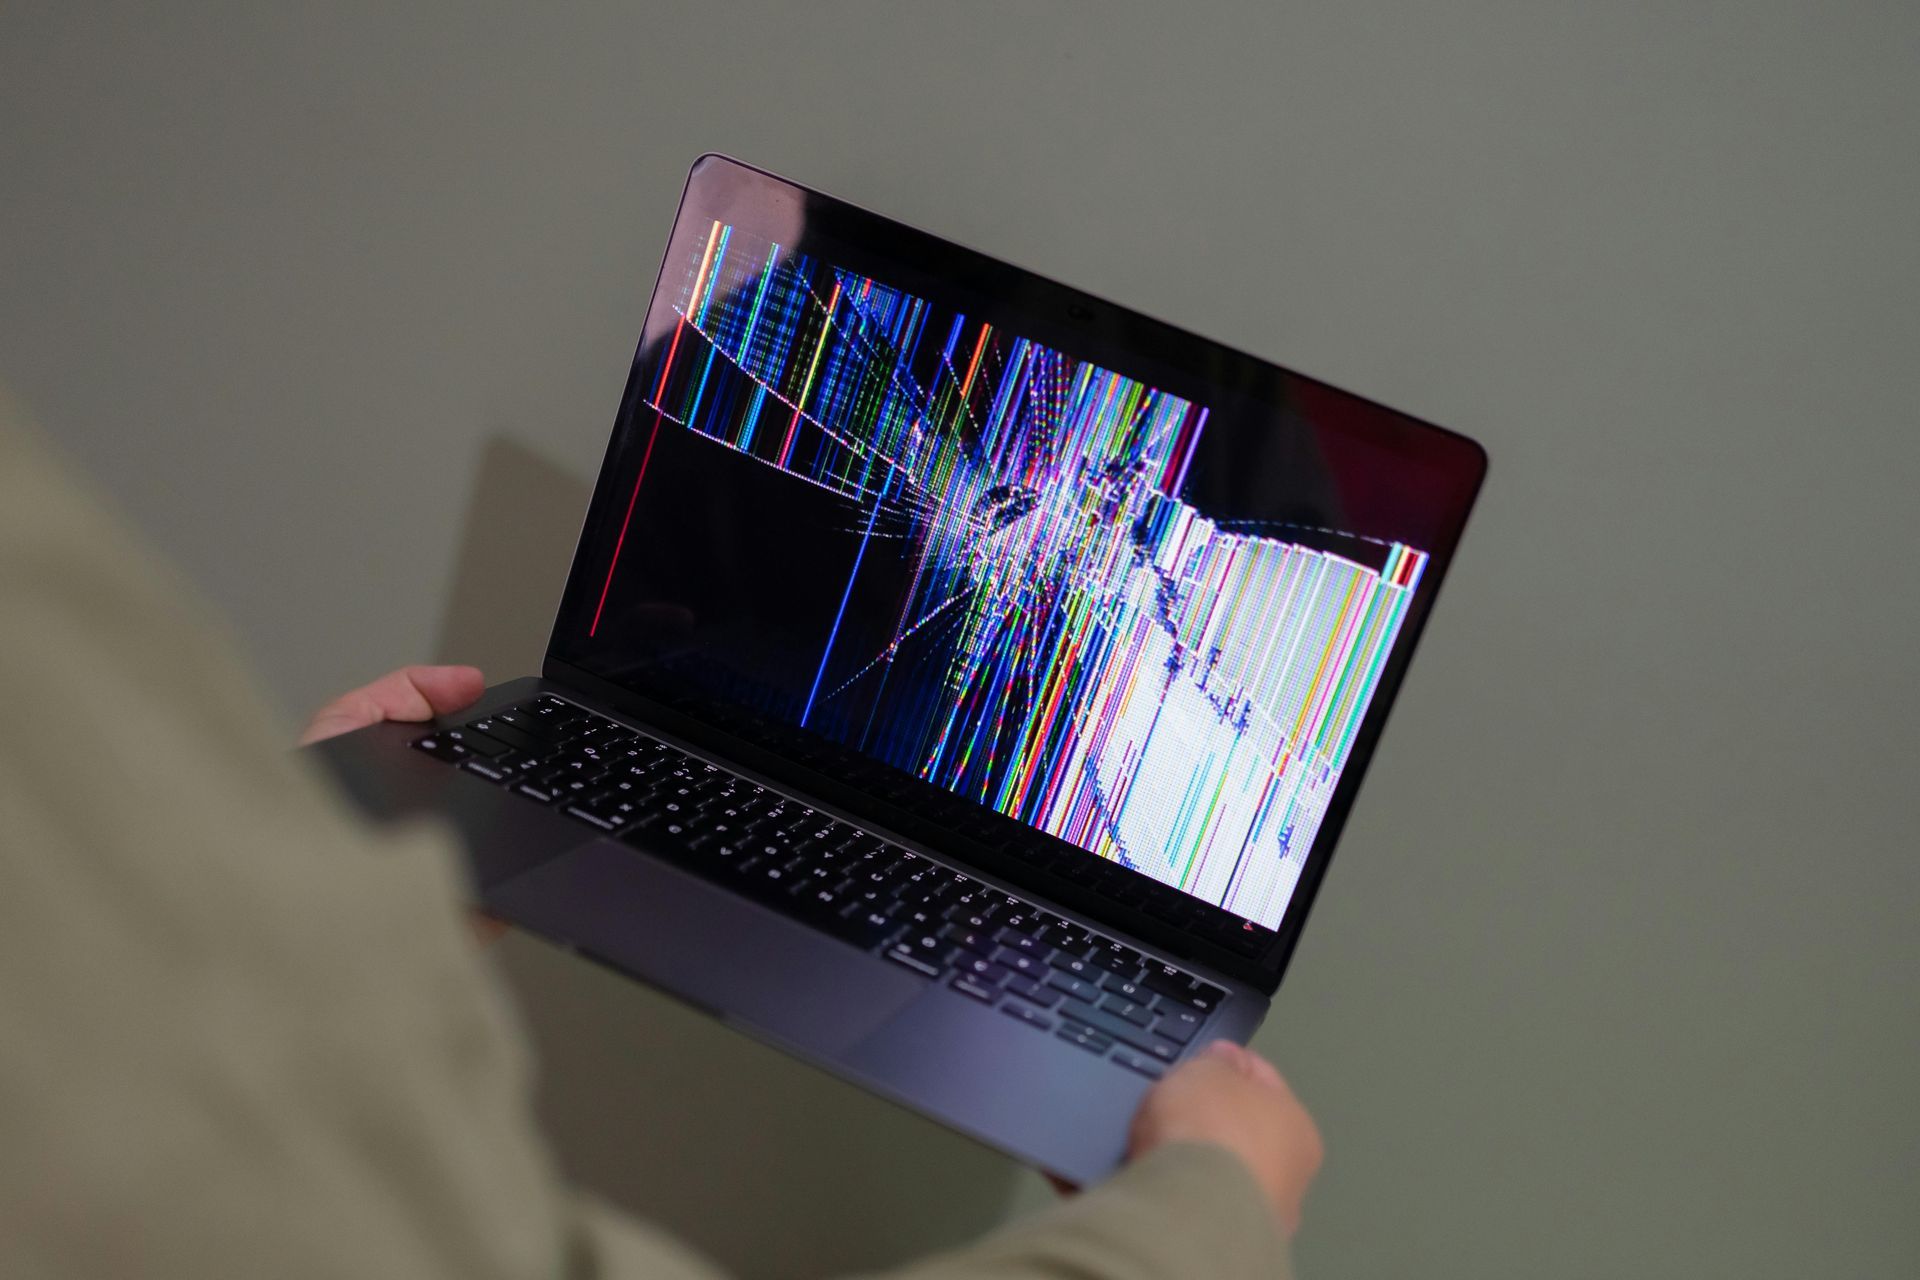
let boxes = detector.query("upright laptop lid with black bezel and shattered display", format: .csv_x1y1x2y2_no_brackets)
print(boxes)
547,155,1486,992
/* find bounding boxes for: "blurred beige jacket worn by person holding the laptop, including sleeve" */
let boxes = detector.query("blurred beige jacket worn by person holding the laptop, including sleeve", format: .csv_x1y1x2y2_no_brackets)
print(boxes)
0,401,1286,1280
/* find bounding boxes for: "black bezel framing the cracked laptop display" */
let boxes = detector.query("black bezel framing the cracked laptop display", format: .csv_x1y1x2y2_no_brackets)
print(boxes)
543,154,1486,992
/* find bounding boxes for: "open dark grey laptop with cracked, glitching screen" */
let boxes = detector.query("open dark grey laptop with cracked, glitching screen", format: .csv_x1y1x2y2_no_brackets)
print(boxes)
313,155,1486,1182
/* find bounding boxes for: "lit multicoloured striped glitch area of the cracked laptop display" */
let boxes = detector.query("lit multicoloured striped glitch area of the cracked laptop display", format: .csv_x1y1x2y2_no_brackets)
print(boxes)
629,223,1427,927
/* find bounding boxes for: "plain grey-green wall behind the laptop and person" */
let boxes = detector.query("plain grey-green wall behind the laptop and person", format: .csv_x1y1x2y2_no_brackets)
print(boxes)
0,0,1920,1278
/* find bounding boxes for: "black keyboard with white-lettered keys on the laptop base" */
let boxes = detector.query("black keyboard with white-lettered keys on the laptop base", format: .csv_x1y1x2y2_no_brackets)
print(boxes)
413,695,1227,1077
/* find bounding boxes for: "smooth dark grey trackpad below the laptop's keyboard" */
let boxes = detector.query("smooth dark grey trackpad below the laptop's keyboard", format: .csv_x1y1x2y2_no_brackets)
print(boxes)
482,839,925,1054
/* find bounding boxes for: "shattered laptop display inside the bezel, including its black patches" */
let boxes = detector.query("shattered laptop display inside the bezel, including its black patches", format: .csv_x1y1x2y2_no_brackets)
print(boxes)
563,221,1459,927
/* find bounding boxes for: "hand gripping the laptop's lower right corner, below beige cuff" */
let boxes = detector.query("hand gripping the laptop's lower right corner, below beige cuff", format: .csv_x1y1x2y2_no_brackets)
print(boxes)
1127,1040,1325,1236
